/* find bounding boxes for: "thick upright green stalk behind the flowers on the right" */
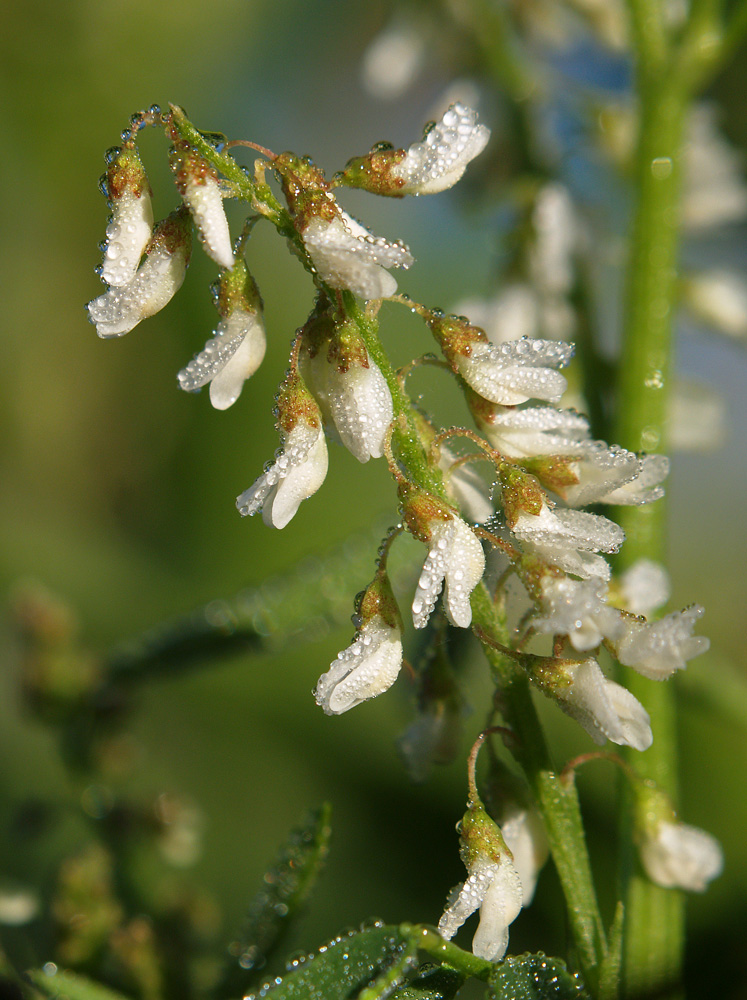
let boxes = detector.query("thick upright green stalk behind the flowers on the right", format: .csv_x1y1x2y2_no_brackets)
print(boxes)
614,65,688,998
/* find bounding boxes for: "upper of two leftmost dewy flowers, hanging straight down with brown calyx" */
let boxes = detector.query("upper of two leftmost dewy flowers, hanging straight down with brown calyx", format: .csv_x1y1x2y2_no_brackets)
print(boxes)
100,146,153,288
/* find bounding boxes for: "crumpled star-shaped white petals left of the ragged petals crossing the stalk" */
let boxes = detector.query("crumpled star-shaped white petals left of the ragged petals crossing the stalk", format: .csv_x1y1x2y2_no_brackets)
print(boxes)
532,576,625,652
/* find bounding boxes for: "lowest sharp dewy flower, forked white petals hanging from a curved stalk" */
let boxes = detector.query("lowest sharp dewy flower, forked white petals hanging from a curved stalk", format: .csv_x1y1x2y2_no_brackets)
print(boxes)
438,802,523,962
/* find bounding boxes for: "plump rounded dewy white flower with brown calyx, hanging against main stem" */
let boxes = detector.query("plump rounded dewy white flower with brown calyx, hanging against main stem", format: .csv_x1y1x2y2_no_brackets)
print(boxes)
301,314,394,462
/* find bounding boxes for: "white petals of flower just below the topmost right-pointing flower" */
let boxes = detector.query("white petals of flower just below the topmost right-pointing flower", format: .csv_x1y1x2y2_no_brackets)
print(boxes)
301,212,413,299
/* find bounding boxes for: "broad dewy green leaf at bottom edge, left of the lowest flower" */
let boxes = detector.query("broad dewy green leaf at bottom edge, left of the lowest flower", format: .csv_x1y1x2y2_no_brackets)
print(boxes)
246,924,415,1000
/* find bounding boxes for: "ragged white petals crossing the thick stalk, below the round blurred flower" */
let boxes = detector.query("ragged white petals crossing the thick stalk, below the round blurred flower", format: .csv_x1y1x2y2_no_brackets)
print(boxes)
614,604,710,681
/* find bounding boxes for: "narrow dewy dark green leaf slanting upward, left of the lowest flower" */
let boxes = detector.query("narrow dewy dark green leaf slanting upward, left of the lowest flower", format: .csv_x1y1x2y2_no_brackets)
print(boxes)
217,803,332,996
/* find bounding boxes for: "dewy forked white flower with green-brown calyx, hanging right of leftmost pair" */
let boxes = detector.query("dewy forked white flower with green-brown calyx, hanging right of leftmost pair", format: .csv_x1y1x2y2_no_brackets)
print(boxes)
177,259,267,410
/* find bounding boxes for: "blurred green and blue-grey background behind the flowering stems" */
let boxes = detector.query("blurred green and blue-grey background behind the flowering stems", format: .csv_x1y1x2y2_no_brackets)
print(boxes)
0,0,747,996
